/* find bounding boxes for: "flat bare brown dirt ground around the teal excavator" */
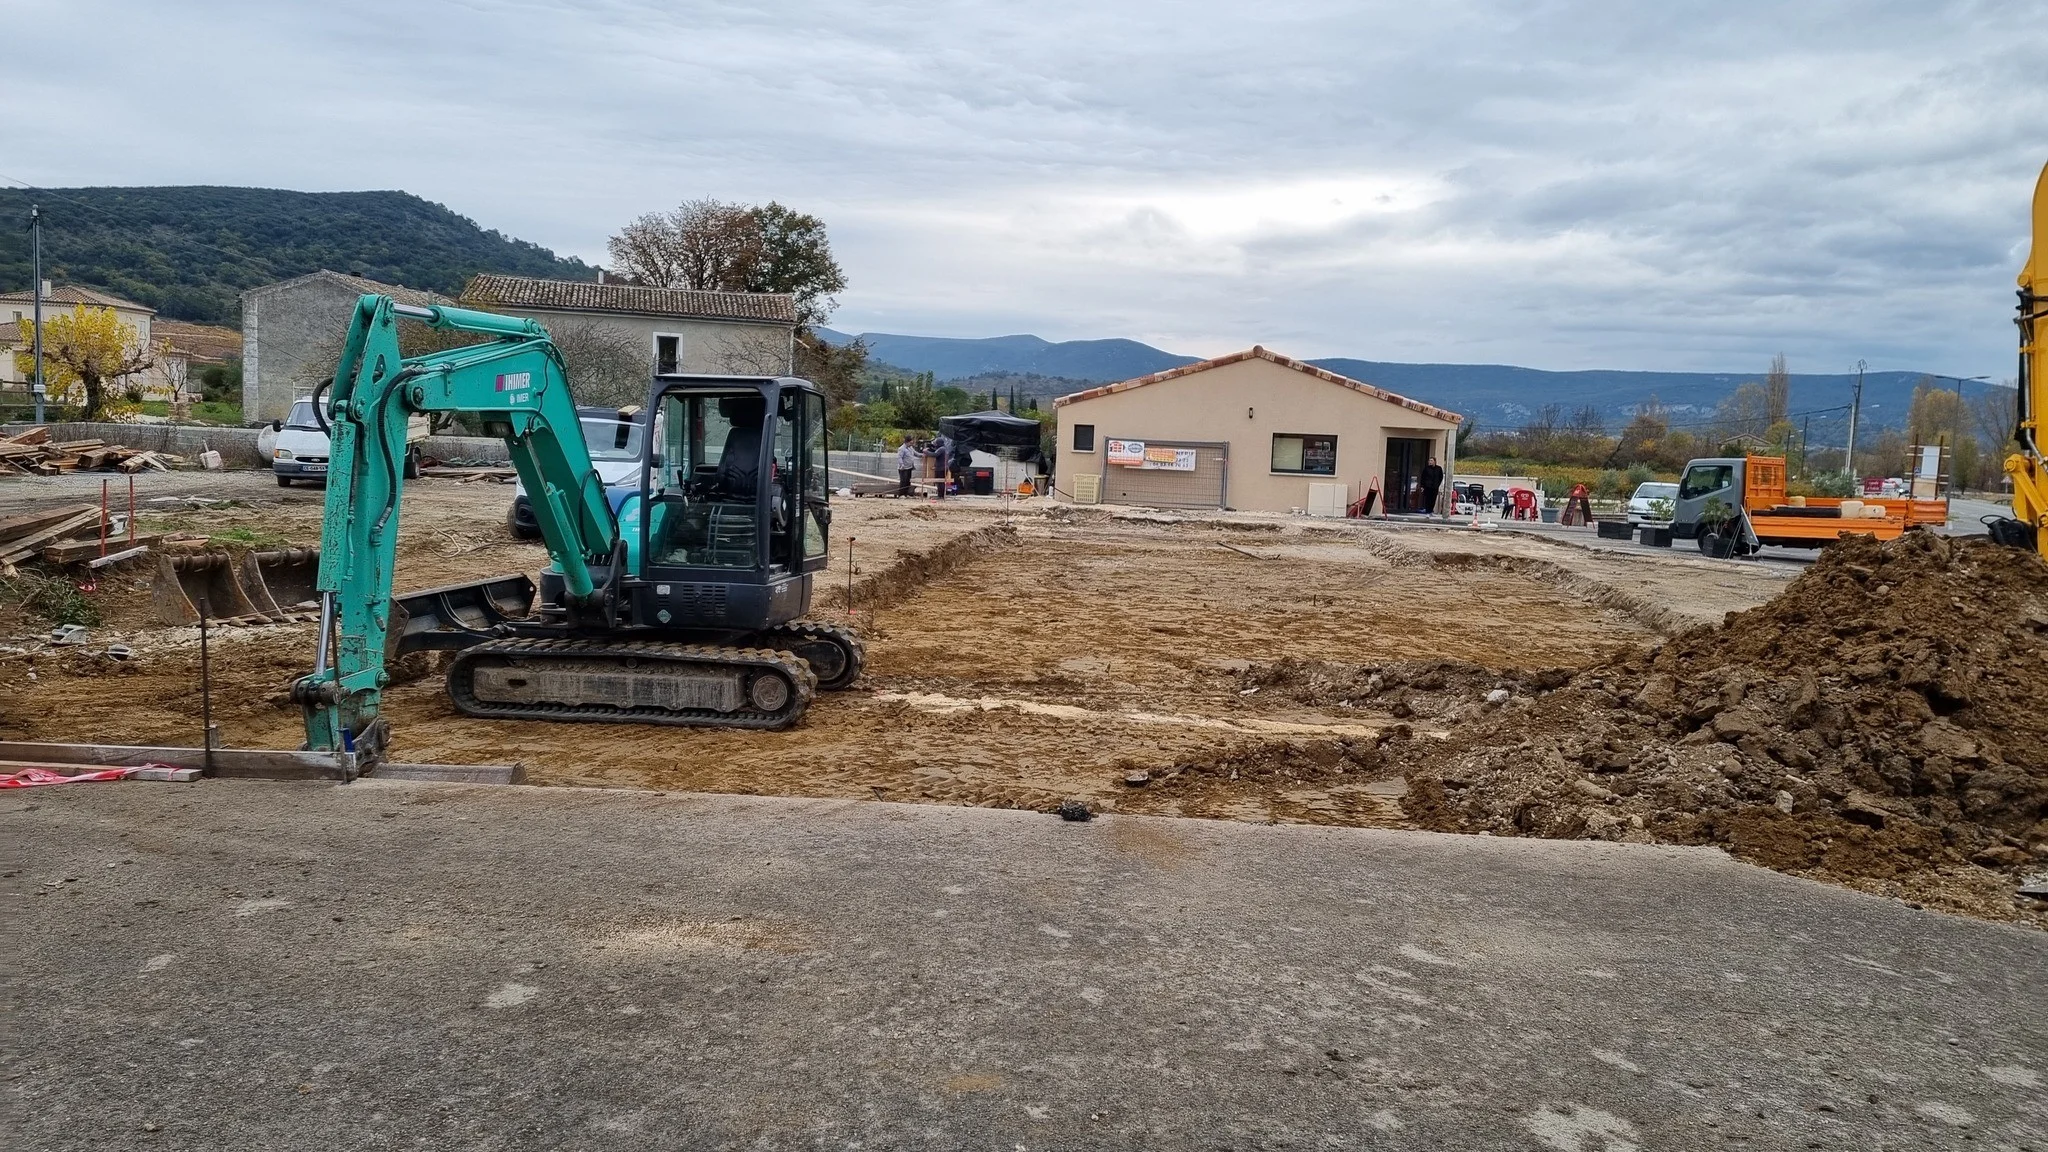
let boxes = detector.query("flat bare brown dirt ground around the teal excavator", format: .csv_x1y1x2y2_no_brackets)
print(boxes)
19,480,2031,912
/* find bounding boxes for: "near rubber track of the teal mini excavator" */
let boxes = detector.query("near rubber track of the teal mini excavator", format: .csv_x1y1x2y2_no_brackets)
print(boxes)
449,640,817,730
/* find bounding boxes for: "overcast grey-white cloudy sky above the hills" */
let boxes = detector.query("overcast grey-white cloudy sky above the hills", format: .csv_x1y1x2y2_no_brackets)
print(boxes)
12,0,2048,377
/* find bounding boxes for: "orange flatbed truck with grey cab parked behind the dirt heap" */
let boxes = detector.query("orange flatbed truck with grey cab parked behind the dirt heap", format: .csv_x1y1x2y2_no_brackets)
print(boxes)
1671,455,1948,556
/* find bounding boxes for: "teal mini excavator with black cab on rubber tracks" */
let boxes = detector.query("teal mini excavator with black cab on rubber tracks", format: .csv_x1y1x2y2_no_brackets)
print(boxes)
291,295,862,760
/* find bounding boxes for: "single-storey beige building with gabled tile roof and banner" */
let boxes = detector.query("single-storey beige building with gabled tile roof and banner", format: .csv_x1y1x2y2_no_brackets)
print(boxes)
1053,348,1464,515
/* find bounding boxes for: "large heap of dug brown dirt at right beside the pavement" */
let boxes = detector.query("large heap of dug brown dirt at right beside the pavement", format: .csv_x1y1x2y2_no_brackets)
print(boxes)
1382,533,2048,918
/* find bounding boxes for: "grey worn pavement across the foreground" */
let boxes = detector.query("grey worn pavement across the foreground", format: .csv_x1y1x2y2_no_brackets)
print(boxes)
0,774,2048,1152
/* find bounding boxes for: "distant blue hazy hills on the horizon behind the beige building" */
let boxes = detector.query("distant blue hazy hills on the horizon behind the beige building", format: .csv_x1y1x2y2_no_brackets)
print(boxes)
823,330,1923,432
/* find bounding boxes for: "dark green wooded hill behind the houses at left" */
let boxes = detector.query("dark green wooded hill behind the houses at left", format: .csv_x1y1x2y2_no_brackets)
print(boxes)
0,187,598,326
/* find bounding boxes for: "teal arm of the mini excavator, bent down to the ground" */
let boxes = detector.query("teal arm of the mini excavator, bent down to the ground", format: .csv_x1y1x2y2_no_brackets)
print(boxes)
293,295,621,754
